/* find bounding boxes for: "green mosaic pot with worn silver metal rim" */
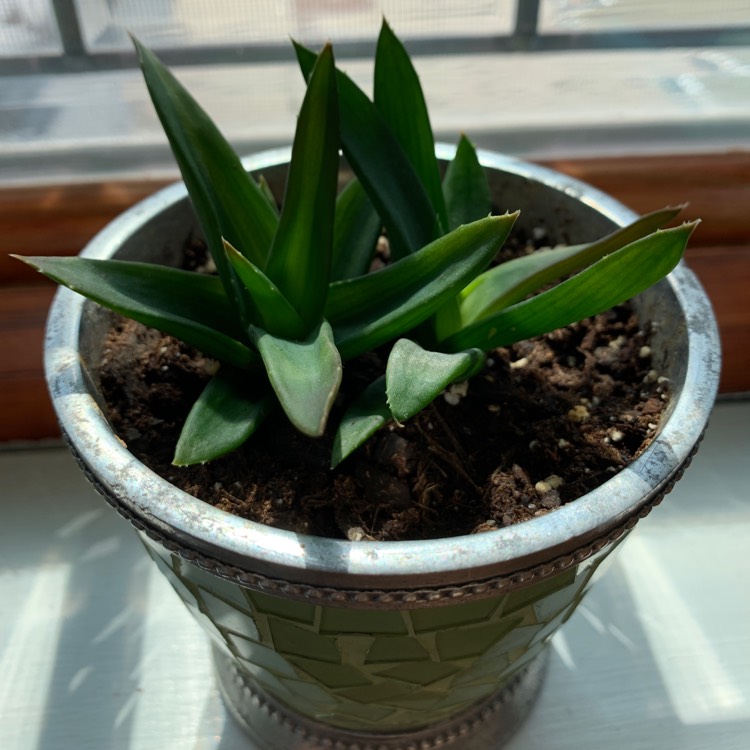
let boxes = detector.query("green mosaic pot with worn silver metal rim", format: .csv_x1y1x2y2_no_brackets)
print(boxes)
46,147,719,750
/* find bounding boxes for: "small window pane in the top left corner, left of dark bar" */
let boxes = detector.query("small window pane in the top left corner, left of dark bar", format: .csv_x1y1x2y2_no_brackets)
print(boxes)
0,0,62,57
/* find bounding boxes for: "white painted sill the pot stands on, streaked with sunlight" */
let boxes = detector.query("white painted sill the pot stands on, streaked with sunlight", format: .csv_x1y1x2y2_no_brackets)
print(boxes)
0,402,750,750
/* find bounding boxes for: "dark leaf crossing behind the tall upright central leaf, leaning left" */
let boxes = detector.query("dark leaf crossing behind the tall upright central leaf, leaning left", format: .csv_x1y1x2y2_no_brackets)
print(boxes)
295,43,436,258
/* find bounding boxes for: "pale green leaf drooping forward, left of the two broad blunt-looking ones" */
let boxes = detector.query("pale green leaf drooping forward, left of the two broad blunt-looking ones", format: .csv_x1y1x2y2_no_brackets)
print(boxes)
251,320,341,437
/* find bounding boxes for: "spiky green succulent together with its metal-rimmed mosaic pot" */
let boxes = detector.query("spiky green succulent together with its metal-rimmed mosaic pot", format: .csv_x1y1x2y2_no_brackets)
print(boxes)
16,24,719,750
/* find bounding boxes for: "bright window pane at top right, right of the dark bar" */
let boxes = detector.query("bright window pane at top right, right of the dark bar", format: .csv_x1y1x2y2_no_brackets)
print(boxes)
539,0,750,34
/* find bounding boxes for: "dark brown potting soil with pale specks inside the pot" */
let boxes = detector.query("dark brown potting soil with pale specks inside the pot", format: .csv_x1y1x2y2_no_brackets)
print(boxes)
95,307,666,540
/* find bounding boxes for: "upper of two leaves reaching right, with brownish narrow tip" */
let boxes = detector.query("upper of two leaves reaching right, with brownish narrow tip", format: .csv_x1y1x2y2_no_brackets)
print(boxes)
452,206,683,333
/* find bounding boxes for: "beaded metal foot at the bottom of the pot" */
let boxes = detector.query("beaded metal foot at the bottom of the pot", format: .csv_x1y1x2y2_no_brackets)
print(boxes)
214,647,548,750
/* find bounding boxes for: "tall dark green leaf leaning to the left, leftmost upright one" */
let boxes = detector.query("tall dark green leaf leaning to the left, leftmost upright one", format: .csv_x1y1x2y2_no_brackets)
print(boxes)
133,39,278,282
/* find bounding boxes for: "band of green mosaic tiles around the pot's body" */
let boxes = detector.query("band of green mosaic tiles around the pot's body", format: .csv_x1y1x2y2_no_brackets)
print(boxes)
141,545,624,732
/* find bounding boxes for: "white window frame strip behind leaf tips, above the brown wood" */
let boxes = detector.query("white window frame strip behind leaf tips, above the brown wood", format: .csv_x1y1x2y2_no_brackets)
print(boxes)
0,47,750,184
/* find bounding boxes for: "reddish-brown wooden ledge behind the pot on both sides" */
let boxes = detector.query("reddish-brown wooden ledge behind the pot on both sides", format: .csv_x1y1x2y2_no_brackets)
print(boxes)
0,151,750,441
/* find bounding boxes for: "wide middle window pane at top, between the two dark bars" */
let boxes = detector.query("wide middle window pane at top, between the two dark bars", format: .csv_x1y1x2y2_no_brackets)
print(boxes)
76,0,515,51
